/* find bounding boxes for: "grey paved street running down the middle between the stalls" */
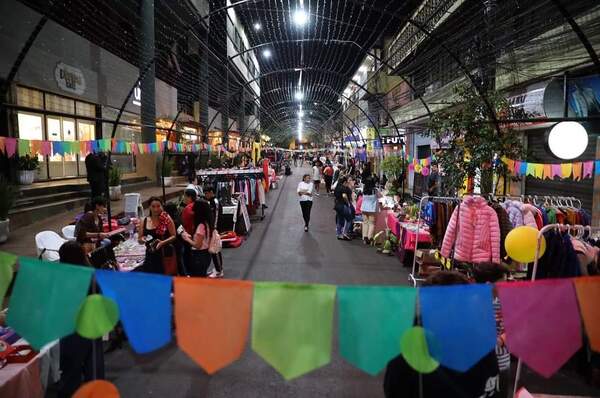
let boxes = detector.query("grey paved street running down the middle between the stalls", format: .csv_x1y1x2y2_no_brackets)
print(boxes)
106,169,407,398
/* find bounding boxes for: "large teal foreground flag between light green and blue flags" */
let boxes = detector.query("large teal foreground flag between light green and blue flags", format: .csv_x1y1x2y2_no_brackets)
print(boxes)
337,286,417,375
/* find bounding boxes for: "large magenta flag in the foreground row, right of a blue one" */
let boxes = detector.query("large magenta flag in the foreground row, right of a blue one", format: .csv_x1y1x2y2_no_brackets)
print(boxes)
496,279,582,378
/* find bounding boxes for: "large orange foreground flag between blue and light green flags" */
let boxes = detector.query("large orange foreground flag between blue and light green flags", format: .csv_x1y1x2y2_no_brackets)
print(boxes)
174,277,254,374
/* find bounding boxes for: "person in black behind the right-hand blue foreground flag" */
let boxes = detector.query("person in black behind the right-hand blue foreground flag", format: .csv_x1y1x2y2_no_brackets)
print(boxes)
383,271,499,398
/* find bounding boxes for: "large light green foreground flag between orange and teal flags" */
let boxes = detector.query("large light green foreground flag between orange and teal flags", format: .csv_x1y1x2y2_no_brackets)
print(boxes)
252,282,335,380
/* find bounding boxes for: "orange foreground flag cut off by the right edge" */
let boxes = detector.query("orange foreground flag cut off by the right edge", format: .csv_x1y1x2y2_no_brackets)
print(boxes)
573,277,600,352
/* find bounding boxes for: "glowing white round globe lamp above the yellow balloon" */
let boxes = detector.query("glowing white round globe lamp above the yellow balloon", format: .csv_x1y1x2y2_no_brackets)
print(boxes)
548,122,588,160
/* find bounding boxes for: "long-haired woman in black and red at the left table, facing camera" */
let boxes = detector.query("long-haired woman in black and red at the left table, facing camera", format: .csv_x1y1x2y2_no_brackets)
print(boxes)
136,196,177,274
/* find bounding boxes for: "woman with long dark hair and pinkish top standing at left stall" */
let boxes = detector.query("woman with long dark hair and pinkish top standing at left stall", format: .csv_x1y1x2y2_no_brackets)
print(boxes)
181,200,215,278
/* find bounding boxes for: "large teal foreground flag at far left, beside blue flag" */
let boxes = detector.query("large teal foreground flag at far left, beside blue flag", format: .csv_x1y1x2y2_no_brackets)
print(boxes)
7,257,94,350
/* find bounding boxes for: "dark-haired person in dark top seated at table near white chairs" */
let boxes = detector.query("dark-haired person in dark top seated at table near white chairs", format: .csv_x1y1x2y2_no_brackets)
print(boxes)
75,196,110,253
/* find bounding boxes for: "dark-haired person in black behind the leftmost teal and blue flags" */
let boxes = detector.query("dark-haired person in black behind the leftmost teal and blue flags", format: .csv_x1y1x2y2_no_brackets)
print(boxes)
58,241,104,398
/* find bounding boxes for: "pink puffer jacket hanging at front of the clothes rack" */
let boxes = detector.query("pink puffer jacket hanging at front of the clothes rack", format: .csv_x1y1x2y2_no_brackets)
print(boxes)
442,196,500,264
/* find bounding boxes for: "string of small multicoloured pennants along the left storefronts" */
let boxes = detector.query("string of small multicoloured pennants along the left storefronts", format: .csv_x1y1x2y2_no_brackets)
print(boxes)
0,137,250,157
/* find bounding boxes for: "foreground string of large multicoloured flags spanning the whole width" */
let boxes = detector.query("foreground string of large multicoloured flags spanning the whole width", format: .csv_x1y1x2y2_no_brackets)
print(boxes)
0,252,600,380
